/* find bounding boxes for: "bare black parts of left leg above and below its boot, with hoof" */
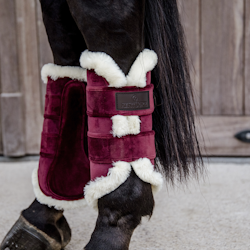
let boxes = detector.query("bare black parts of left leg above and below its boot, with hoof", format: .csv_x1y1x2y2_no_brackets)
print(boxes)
0,0,86,250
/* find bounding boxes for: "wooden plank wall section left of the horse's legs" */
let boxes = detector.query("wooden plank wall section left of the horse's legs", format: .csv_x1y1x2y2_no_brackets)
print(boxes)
0,0,52,156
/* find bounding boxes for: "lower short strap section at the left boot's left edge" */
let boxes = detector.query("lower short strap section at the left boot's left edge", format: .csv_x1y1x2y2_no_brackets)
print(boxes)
41,133,58,155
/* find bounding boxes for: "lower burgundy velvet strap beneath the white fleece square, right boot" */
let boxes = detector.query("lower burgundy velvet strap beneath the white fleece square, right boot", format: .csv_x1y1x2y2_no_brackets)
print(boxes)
88,131,156,163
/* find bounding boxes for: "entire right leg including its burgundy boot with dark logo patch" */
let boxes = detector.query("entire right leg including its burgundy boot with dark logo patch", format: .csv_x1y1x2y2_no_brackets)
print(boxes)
68,0,162,250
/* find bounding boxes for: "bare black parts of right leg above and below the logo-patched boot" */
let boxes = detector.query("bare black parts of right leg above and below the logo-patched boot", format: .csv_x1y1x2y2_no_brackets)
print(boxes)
67,0,154,250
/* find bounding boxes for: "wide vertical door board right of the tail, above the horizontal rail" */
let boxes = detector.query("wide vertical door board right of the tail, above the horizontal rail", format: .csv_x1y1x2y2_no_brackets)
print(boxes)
201,0,244,115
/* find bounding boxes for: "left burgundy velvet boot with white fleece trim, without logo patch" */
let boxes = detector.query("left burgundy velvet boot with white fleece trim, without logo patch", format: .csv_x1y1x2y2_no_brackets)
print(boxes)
32,64,90,209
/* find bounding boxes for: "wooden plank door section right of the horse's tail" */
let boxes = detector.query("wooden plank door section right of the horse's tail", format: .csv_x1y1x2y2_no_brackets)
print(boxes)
179,0,250,156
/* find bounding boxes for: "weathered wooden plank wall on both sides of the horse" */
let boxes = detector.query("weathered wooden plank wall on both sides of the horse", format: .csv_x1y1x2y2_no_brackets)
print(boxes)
0,0,250,156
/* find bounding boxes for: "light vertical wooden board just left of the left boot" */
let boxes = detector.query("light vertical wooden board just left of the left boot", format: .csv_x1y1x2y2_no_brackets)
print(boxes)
15,0,43,154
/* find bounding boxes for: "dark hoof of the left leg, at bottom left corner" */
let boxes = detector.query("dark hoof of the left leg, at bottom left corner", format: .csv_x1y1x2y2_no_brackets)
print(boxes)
0,215,62,250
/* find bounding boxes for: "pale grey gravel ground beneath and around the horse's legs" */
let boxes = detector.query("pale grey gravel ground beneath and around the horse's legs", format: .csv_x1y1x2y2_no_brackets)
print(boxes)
0,161,250,250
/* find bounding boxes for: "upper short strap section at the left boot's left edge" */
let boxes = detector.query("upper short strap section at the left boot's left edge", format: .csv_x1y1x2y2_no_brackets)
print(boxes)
44,95,61,116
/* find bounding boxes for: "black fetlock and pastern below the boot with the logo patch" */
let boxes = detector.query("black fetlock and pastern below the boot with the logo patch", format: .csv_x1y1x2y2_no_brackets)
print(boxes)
85,171,154,250
